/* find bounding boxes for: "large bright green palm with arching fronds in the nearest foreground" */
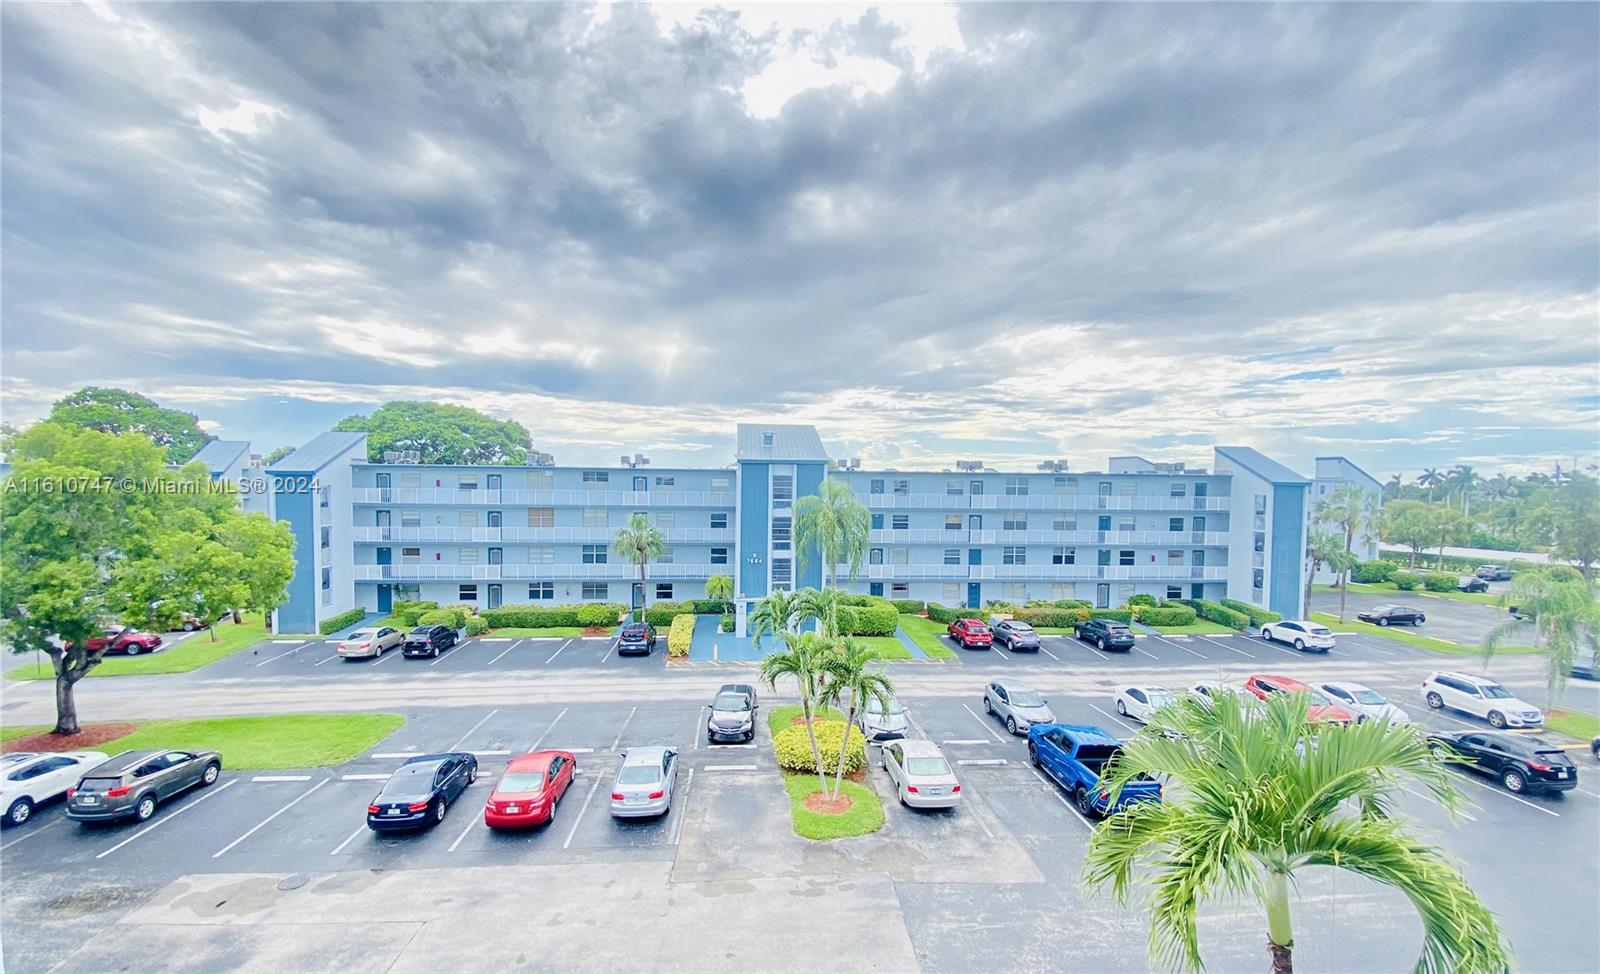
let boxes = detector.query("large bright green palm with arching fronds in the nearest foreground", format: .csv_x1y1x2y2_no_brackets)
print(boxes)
1083,694,1510,974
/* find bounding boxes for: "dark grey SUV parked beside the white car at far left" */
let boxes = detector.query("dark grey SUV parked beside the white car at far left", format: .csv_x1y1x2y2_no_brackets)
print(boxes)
67,750,222,822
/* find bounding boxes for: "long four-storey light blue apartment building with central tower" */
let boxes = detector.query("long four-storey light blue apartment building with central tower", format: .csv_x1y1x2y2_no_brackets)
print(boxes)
267,424,1337,632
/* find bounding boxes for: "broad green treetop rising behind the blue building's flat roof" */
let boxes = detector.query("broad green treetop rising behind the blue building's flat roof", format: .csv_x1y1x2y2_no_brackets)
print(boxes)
333,400,533,465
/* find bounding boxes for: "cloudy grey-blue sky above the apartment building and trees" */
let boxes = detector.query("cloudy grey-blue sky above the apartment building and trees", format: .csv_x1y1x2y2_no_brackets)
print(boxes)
0,3,1600,478
